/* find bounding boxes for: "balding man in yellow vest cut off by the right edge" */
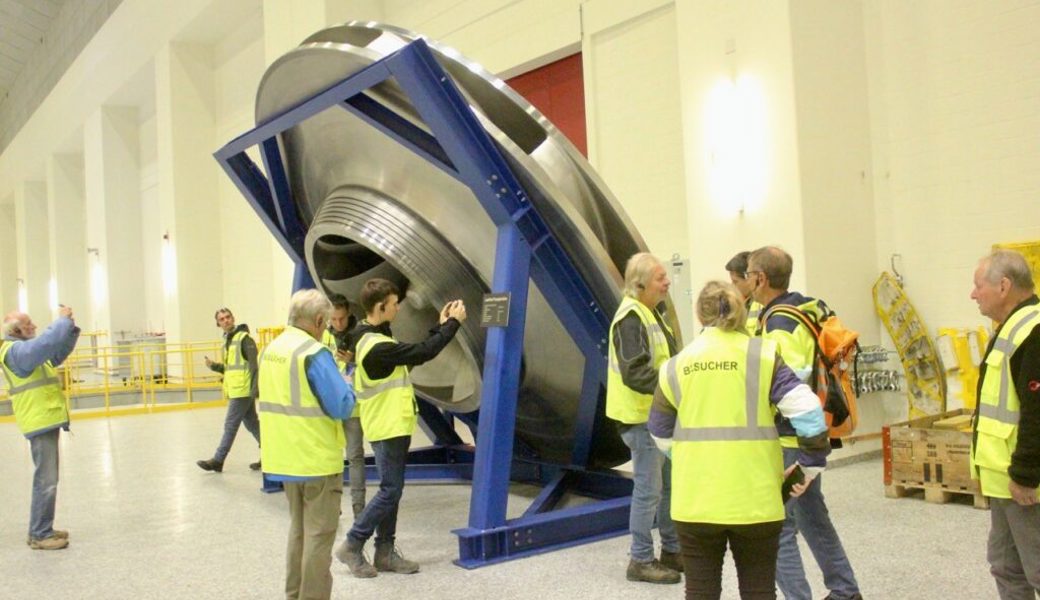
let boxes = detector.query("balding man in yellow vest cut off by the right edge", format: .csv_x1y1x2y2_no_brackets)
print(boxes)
971,250,1040,600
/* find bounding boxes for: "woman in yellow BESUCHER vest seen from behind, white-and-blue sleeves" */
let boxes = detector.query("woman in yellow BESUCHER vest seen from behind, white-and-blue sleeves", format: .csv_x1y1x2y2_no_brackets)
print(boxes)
648,282,830,599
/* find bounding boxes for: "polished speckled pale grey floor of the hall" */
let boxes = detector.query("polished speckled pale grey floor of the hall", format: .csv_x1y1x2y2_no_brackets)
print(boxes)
0,409,996,600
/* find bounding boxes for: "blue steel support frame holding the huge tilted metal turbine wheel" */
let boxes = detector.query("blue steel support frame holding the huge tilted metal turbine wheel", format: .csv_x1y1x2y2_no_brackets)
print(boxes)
214,40,631,568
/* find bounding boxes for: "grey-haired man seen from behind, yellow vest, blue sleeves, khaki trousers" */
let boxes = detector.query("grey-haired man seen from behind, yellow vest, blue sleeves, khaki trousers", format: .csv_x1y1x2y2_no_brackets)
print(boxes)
259,289,354,599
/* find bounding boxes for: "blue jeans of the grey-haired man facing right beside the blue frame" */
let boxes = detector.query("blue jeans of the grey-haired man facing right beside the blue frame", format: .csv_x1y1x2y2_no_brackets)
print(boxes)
621,423,679,563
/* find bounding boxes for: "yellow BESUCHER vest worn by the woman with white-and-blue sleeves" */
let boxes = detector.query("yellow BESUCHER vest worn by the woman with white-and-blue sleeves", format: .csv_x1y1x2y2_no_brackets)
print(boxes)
659,328,784,524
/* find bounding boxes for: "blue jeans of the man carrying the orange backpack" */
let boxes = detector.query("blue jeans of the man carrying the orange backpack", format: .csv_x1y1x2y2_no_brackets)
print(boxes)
777,448,859,600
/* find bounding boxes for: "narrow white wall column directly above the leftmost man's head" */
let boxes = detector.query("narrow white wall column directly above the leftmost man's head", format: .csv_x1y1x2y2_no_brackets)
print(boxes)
15,181,52,325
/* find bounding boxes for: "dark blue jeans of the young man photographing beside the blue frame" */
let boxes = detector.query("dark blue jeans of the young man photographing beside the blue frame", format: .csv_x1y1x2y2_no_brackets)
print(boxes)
346,436,412,546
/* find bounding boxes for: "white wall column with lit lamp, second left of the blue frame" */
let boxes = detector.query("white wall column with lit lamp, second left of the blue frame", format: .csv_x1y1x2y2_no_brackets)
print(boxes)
83,106,145,336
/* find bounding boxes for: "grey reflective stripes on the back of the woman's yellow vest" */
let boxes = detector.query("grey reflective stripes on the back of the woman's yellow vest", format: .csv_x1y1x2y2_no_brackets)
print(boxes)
664,338,778,442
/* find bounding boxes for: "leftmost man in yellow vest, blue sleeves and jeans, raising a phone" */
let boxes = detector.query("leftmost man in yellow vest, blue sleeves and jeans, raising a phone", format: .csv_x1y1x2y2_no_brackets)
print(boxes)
0,306,79,550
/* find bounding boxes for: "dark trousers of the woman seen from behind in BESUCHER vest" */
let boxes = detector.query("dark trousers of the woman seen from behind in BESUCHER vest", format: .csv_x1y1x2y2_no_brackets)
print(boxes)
675,521,783,600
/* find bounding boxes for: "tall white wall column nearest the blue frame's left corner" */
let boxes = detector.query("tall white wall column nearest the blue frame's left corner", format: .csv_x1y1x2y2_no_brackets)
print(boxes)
147,43,224,343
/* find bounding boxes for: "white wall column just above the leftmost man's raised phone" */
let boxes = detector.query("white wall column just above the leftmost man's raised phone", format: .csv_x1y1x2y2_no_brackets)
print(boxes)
47,154,94,323
